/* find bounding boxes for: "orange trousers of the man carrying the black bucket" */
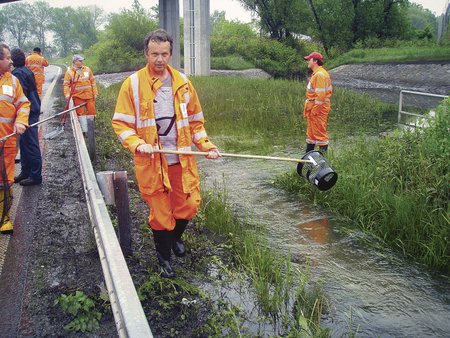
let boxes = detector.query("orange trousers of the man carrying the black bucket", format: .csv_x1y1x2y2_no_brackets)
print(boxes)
142,163,201,231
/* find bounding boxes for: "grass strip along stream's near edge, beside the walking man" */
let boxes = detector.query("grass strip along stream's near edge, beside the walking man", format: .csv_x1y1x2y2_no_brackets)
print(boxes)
198,189,328,337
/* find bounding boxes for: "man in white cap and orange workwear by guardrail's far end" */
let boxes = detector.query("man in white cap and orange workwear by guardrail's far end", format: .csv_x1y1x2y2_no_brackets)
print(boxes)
63,54,98,132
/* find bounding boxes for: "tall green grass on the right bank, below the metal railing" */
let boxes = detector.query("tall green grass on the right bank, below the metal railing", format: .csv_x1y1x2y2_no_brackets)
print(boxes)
277,99,450,273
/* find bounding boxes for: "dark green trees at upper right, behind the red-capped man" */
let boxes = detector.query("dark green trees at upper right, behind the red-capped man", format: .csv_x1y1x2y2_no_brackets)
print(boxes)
239,0,437,54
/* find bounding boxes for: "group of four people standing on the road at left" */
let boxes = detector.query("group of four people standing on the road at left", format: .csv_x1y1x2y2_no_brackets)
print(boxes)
0,42,98,234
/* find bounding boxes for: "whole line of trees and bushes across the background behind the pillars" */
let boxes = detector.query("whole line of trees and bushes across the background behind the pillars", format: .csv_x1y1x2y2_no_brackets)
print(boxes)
0,0,437,76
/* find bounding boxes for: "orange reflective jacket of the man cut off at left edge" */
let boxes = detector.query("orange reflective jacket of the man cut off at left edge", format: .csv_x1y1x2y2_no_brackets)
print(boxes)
0,72,30,147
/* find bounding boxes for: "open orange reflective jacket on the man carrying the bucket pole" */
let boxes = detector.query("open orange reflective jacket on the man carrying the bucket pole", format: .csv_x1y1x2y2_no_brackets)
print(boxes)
112,65,216,195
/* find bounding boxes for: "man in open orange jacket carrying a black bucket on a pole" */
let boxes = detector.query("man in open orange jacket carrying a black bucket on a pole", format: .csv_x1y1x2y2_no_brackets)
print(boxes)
112,29,221,278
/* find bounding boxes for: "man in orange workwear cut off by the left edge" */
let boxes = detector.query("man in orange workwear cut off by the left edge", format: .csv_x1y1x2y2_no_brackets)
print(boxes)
0,42,30,234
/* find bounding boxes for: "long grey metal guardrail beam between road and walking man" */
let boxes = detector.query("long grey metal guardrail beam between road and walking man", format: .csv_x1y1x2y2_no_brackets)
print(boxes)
70,111,153,338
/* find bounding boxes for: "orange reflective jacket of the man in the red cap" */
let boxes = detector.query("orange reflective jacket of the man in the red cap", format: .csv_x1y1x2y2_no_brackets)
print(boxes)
304,66,333,117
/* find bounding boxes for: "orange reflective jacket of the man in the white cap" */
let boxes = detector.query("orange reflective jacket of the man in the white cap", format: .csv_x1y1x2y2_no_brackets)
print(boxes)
63,66,98,100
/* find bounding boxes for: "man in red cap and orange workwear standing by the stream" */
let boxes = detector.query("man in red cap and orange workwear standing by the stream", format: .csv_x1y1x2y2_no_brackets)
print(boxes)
303,52,333,152
